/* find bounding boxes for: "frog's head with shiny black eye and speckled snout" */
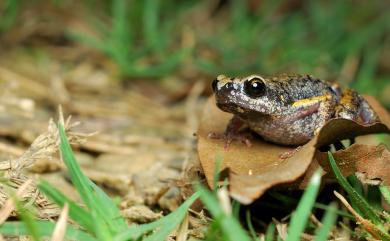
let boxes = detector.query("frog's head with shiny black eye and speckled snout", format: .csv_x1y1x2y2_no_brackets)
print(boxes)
212,75,283,115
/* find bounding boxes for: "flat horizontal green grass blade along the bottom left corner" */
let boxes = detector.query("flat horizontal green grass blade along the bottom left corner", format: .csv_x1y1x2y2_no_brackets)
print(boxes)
0,221,97,241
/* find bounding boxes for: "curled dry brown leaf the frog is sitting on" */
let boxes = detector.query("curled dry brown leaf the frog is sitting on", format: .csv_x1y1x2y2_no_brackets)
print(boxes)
197,97,390,204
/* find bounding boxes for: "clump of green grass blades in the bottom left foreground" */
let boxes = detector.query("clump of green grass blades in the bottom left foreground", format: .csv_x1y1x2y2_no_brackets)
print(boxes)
0,124,199,241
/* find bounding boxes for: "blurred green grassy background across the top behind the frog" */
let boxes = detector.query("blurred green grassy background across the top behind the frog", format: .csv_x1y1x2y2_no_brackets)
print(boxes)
0,0,390,107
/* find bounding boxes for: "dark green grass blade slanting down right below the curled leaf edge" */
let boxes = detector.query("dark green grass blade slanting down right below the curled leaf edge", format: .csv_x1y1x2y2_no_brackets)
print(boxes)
328,152,381,224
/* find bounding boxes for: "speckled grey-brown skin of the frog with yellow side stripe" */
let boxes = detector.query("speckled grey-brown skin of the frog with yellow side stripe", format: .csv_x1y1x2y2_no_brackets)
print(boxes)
213,74,377,145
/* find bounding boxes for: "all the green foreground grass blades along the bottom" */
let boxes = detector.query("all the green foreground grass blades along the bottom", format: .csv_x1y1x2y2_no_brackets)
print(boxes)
0,123,389,241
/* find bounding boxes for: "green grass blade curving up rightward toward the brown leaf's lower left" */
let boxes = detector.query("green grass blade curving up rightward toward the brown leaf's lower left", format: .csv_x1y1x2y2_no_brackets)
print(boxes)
114,193,199,241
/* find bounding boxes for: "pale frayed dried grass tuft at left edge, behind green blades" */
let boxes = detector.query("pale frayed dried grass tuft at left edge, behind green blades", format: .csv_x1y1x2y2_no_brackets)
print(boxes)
0,118,86,218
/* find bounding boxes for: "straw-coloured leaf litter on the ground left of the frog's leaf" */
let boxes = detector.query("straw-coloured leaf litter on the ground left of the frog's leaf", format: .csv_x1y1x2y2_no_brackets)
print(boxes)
0,44,204,236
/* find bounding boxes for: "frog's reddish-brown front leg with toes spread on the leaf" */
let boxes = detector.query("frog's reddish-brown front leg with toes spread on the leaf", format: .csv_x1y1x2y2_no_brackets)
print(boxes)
208,116,252,149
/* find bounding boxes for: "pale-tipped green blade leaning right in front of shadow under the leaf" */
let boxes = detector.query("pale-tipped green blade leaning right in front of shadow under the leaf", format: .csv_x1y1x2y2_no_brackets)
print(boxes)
286,170,321,241
